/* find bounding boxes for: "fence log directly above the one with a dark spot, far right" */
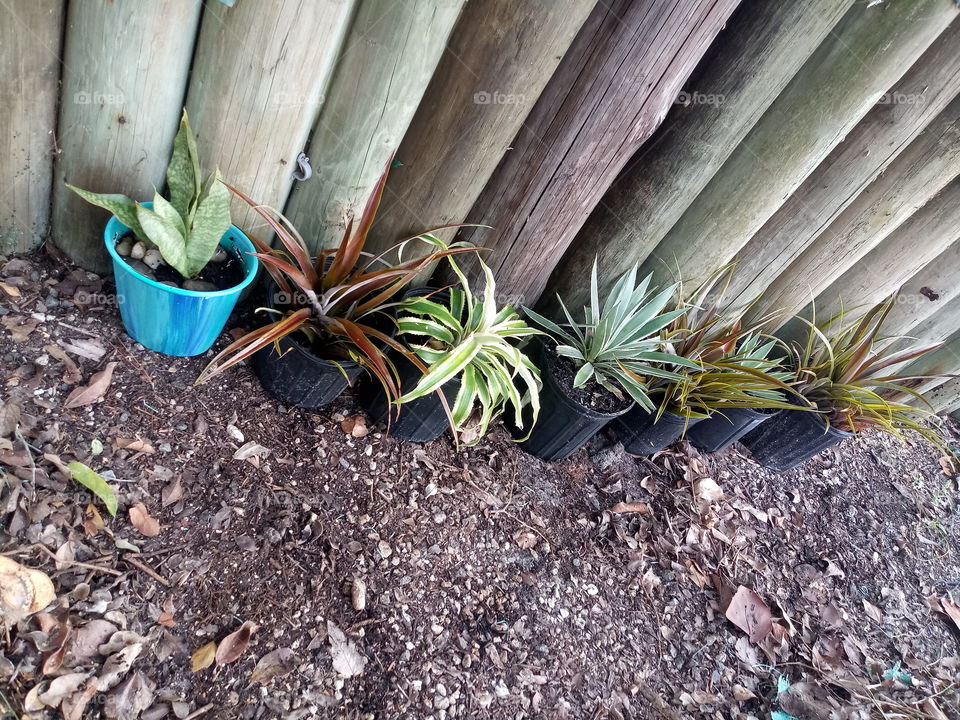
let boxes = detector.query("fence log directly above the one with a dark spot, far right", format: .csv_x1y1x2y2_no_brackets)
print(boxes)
801,179,960,324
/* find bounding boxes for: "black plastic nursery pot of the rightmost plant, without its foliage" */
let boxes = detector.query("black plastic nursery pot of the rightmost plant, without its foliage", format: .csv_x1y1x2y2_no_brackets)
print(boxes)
740,410,853,472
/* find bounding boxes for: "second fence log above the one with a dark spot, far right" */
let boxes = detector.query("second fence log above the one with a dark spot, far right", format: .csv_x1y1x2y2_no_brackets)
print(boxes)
748,97,960,326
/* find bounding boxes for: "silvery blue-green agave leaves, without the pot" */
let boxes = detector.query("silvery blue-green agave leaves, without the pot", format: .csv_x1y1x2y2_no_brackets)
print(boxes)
524,260,699,411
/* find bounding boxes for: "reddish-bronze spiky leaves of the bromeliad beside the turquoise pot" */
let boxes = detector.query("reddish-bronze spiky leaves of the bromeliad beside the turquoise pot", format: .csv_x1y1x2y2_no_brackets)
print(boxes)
197,156,475,401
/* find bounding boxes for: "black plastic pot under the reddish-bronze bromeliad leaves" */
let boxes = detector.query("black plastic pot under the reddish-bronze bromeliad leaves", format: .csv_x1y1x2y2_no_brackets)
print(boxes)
253,336,361,410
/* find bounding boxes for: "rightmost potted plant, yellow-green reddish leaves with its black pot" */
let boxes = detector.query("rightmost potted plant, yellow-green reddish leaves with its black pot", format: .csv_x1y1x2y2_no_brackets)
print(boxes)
741,296,944,471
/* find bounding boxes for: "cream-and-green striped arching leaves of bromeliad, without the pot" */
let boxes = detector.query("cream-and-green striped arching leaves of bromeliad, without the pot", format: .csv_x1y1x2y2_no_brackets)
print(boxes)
397,257,540,445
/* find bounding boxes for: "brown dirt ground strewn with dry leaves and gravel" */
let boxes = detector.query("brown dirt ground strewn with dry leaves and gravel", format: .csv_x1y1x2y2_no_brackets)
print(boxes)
0,249,960,720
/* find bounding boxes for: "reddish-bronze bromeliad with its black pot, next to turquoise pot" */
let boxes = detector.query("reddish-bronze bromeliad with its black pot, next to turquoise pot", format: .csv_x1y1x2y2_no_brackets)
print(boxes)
197,163,475,408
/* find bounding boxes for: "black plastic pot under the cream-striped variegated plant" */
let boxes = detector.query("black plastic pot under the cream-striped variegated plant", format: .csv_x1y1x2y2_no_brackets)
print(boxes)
360,353,460,442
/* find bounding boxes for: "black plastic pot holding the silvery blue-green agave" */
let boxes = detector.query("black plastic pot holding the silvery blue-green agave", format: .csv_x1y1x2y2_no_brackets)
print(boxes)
511,341,633,460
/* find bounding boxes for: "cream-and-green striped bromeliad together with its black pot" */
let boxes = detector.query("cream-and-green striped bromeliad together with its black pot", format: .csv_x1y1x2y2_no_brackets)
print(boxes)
368,257,540,445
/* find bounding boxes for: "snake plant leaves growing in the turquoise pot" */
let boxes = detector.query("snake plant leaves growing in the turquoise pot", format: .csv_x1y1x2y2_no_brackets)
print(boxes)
67,110,230,278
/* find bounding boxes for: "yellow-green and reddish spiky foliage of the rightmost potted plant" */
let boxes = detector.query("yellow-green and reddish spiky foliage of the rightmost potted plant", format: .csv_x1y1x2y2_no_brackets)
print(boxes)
791,295,943,446
